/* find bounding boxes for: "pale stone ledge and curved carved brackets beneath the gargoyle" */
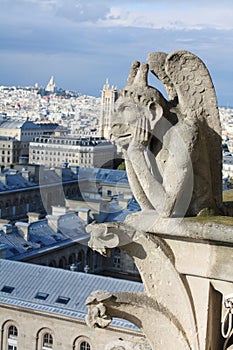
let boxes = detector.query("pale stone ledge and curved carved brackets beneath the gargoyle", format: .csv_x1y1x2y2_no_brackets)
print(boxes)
85,215,233,350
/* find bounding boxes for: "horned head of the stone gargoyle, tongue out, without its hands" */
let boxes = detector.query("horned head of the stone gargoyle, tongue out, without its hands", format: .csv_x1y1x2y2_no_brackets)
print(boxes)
111,61,168,148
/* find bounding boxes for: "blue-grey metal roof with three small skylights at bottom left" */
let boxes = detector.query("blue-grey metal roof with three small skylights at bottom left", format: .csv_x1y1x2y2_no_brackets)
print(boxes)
0,259,143,329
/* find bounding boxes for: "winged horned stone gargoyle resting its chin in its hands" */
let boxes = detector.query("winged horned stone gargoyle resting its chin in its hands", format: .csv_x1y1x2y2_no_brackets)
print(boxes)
111,51,222,217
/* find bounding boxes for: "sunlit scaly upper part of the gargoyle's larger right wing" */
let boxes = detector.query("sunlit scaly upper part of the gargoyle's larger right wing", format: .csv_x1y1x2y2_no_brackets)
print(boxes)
165,51,221,135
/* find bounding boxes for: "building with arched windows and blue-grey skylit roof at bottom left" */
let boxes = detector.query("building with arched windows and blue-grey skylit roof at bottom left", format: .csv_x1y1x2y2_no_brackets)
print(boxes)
0,259,145,350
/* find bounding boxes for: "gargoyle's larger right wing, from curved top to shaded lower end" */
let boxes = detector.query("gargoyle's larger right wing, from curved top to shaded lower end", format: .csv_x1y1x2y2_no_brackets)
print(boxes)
165,51,222,208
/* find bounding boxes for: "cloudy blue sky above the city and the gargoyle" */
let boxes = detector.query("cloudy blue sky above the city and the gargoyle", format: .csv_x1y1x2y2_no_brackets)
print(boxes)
0,0,233,106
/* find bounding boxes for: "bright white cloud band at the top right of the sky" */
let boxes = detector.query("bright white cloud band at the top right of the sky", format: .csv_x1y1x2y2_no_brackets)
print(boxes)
101,1,233,30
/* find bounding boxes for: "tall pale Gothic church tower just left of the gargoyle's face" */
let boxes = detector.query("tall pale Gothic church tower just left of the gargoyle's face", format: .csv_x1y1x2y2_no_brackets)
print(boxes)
99,79,118,139
